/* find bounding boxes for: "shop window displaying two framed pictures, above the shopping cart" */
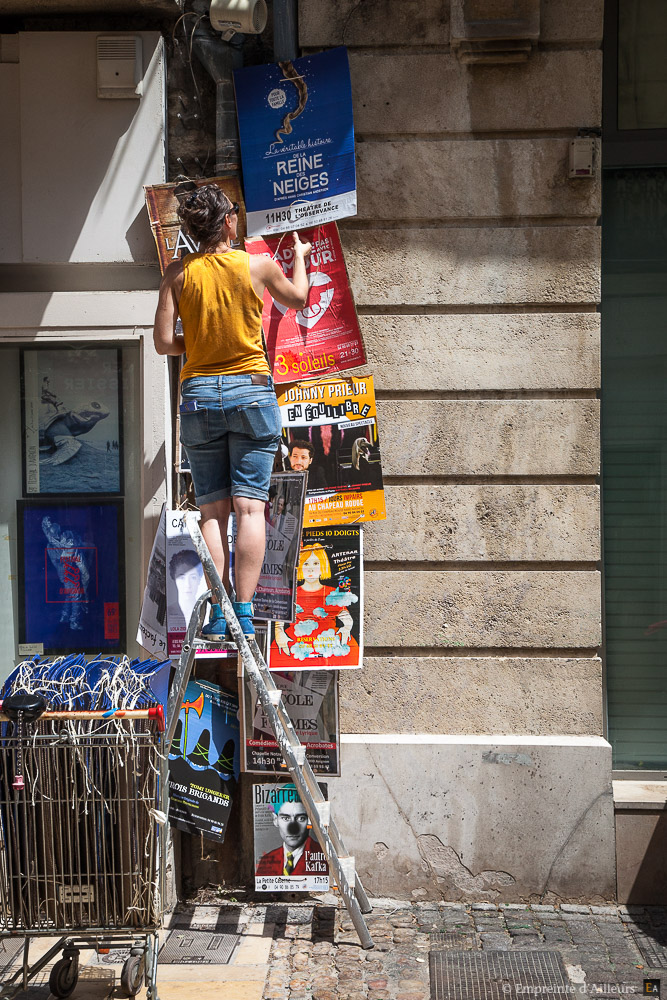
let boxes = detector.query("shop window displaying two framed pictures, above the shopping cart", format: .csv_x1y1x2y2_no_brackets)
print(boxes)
0,341,142,680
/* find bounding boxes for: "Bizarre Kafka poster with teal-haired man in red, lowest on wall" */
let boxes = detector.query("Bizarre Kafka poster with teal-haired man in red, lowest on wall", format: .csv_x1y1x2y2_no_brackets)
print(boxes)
252,784,329,892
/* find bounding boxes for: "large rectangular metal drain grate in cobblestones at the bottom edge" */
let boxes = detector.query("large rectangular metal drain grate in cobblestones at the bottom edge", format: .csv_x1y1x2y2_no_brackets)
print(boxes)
430,951,572,1000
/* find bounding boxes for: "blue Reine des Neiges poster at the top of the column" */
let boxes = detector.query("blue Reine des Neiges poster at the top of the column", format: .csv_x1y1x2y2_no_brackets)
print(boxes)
234,47,357,236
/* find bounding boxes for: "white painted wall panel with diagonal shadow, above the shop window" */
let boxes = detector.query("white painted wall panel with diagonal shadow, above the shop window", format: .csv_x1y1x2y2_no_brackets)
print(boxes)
0,31,165,264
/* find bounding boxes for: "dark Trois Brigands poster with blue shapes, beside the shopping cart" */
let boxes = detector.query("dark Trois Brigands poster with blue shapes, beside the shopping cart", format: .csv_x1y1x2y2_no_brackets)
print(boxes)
169,681,241,843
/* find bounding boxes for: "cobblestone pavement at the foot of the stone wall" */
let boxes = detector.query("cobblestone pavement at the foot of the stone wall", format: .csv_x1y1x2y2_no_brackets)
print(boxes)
258,900,667,1000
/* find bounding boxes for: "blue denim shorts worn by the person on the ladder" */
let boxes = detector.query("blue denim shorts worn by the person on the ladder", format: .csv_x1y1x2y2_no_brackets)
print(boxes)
181,375,282,506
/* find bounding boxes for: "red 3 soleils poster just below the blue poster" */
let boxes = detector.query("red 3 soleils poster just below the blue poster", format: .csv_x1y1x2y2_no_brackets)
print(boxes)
245,222,366,382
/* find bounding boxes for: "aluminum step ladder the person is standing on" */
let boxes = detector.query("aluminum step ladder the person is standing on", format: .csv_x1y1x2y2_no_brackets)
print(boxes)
167,511,373,948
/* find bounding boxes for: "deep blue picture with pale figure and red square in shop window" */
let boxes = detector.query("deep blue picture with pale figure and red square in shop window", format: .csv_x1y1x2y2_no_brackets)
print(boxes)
17,499,125,653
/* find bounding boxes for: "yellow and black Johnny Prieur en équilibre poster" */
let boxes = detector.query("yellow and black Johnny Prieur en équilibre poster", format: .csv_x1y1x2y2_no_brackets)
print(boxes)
277,375,387,528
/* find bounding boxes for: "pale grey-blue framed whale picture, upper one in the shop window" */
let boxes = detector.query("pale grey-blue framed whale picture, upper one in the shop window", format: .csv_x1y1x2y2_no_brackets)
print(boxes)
21,346,123,497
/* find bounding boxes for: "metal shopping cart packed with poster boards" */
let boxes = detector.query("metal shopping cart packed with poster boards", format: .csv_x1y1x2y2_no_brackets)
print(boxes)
0,694,167,1000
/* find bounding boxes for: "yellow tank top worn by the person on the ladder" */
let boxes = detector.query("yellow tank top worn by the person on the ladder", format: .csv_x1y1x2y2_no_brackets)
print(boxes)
178,250,271,381
